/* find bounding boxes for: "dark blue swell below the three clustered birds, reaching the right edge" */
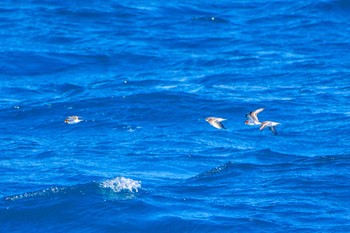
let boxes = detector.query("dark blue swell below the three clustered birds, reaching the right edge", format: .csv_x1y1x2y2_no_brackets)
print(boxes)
186,149,350,185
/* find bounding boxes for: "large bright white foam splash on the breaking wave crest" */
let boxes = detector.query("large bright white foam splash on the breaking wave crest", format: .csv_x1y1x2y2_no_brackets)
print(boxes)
100,177,141,193
